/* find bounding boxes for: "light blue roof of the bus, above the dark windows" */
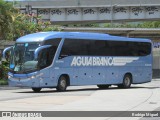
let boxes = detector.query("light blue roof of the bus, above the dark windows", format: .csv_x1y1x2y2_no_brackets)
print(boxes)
16,32,151,43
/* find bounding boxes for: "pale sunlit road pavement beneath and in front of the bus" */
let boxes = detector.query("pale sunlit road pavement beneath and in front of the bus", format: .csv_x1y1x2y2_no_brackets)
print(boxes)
0,79,160,120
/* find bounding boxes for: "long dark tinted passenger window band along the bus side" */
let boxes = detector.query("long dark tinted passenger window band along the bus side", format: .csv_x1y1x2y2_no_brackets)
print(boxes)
60,39,151,58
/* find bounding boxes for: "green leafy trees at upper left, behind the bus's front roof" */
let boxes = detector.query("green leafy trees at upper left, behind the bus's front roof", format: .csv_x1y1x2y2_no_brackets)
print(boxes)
0,0,60,40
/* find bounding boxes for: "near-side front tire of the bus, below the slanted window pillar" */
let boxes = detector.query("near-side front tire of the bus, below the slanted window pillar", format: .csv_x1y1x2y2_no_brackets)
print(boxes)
56,76,67,92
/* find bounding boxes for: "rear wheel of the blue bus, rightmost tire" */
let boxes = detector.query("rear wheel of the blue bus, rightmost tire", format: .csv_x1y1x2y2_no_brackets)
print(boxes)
118,74,132,88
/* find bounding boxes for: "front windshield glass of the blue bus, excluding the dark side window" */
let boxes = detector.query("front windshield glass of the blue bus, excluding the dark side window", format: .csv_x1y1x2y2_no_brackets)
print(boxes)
10,43,40,73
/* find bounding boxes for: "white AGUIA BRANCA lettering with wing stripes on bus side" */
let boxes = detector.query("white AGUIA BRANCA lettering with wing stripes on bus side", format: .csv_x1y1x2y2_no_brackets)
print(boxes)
71,56,139,66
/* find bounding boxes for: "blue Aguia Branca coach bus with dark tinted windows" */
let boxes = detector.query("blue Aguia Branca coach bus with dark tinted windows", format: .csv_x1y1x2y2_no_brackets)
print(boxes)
3,32,152,92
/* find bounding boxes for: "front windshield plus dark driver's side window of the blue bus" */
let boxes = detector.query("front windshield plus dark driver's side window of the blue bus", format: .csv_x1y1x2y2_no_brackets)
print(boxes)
10,38,61,74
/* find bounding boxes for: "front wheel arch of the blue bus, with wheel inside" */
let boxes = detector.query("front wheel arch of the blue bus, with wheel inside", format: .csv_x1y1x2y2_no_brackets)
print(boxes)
56,74,70,92
